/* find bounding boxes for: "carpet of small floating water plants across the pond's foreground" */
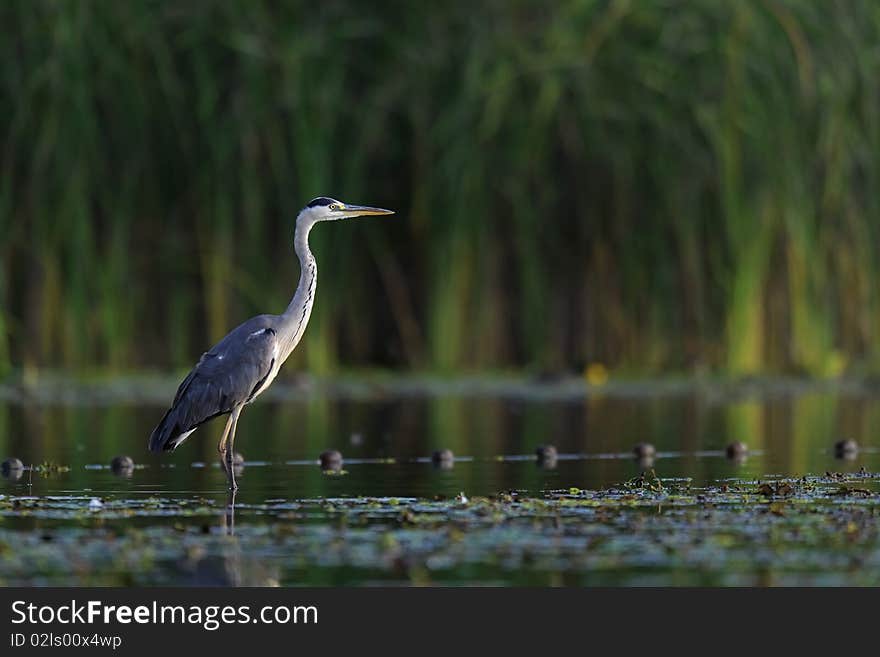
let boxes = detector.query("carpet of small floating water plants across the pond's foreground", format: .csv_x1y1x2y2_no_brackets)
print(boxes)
0,472,880,585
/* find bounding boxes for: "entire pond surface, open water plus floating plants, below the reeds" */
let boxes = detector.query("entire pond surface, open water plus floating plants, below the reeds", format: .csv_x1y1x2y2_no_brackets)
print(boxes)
0,389,880,586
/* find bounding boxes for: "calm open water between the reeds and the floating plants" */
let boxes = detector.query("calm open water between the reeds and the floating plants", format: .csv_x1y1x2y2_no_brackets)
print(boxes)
0,386,880,502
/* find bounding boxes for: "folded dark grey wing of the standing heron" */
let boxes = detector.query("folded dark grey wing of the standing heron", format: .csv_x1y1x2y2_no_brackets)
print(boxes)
150,317,278,452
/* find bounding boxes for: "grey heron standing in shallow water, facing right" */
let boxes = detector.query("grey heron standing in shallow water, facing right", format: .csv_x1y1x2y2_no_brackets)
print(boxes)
150,196,394,491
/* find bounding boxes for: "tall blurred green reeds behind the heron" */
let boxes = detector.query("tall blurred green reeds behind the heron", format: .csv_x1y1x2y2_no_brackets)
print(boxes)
0,0,880,376
